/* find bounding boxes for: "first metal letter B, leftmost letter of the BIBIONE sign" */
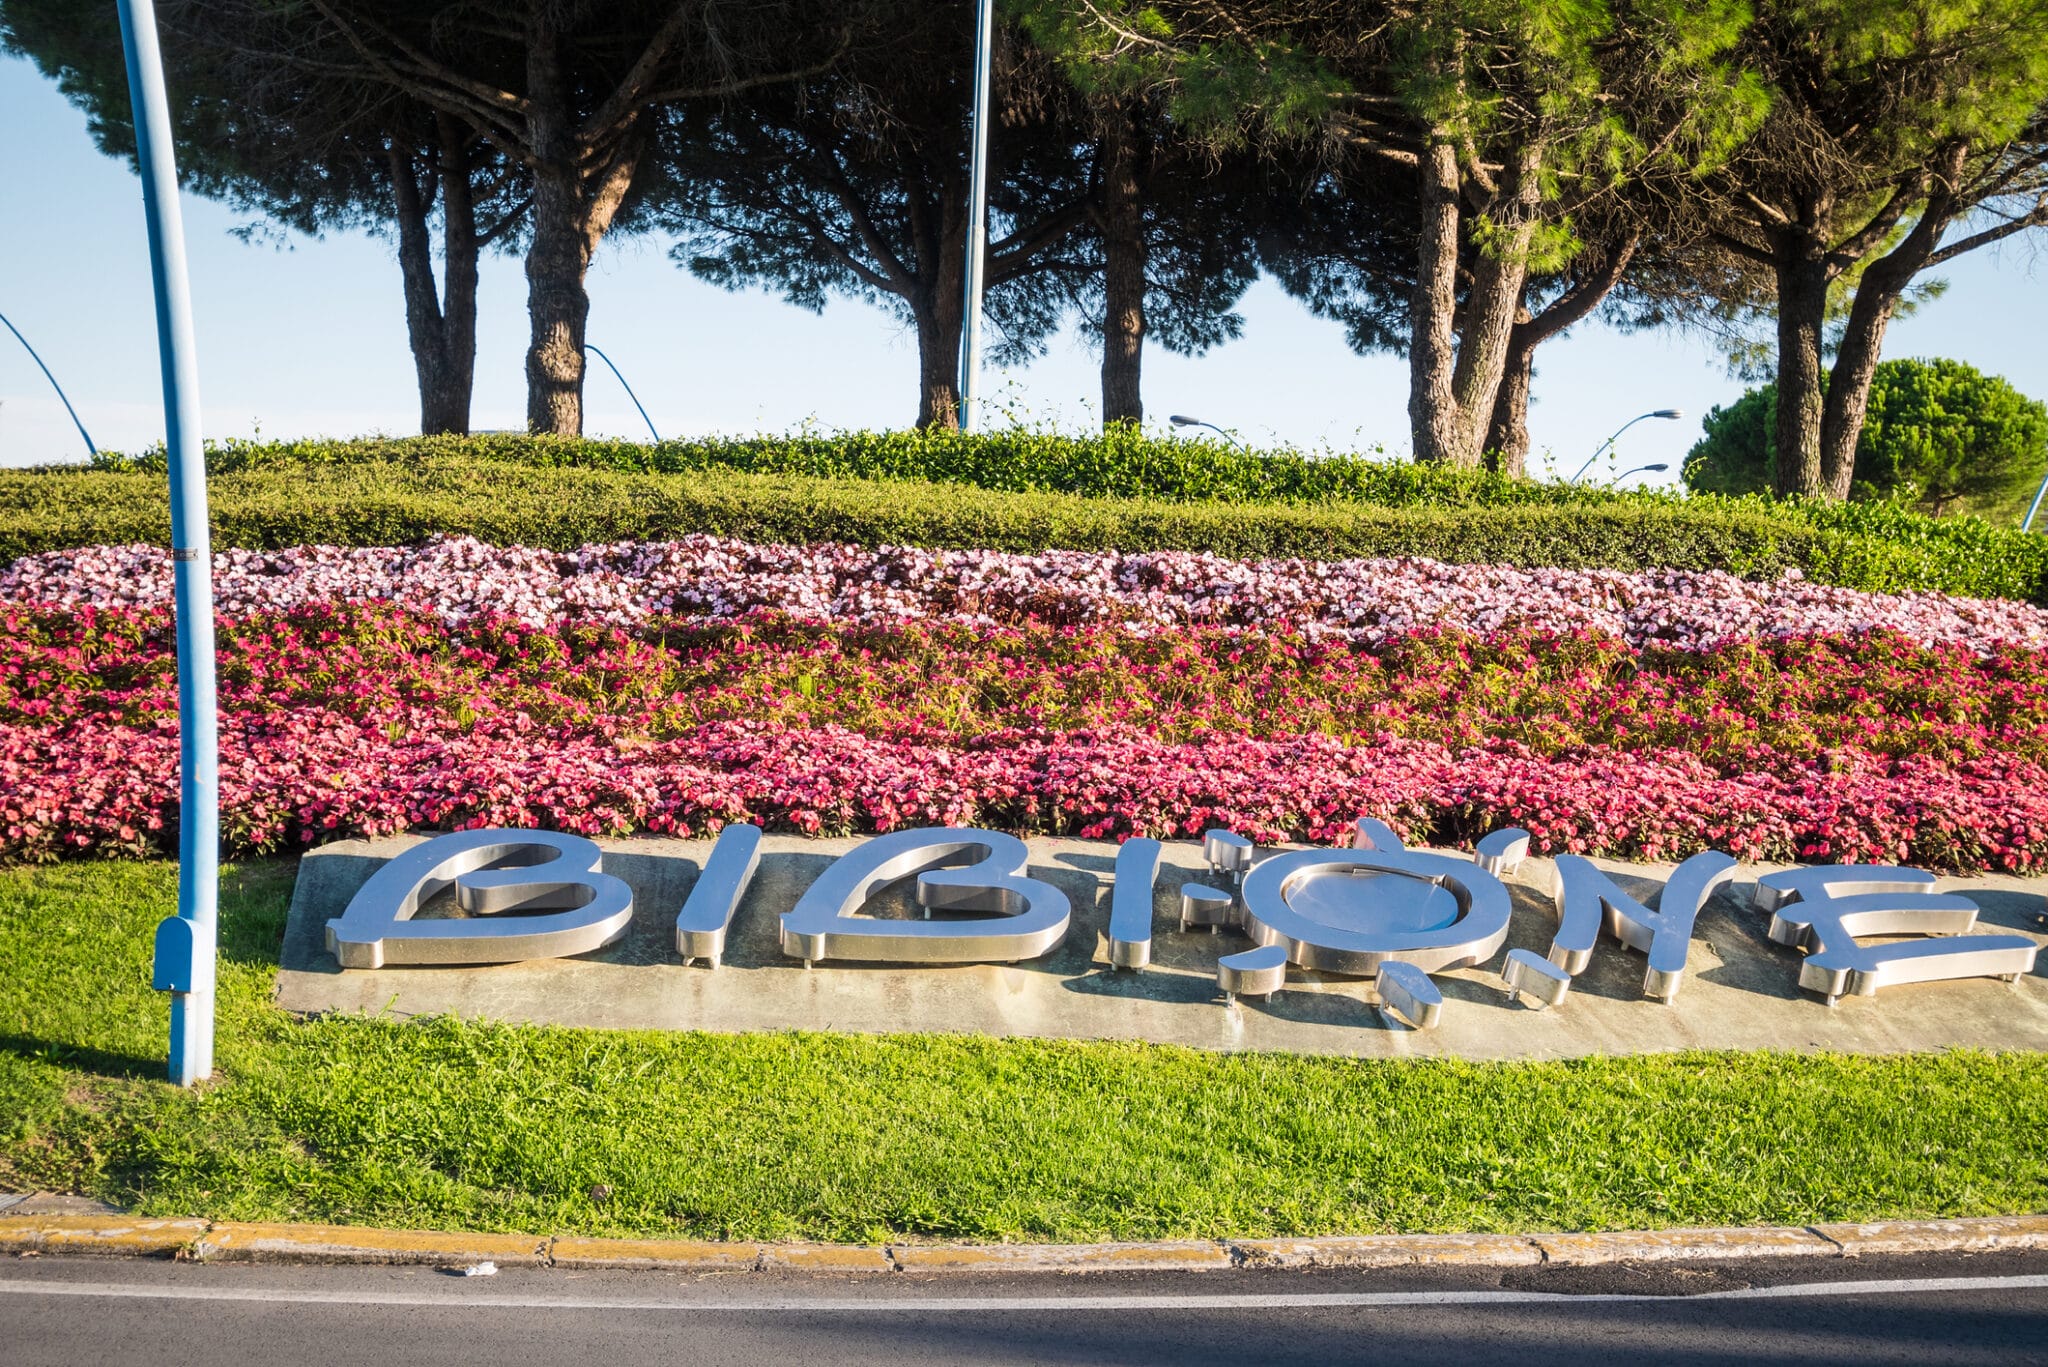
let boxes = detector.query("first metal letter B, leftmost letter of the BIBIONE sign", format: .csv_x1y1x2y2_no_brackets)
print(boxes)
328,830,633,967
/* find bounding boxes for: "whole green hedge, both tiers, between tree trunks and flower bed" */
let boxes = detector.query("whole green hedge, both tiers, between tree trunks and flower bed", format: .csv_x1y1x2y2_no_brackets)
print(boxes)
12,432,2048,598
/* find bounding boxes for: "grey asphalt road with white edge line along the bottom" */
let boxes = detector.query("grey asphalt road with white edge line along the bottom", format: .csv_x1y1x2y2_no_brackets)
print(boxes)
0,1254,2048,1367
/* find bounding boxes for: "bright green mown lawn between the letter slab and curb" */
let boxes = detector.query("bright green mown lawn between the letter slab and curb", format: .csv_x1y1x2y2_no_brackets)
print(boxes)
0,861,2048,1240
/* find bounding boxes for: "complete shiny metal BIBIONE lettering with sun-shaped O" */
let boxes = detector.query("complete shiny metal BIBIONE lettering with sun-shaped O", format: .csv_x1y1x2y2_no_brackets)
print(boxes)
326,818,2036,1027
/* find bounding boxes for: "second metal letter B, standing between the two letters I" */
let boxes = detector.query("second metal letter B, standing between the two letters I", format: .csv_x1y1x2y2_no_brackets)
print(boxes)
782,826,1073,967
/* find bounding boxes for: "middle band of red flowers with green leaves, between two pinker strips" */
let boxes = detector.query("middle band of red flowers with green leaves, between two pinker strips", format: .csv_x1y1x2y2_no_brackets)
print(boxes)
12,605,2048,773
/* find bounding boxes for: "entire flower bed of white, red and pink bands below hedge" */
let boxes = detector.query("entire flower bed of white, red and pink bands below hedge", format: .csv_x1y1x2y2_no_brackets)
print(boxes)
12,537,2048,869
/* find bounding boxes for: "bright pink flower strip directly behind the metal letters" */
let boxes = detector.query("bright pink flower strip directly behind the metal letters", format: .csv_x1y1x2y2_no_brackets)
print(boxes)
0,709,2048,869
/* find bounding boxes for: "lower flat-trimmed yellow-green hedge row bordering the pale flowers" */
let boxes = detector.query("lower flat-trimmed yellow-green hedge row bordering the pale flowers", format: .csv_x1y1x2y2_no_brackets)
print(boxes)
0,455,2048,598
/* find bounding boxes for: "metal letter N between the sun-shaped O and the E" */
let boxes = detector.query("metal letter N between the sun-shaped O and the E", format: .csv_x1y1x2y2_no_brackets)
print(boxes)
1550,851,1735,1006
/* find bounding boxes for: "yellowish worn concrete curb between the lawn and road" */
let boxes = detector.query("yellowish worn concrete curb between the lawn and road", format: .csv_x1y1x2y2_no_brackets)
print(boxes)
0,1215,2048,1277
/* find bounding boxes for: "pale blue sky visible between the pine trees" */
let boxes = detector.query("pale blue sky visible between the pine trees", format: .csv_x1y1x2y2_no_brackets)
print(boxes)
0,57,2048,482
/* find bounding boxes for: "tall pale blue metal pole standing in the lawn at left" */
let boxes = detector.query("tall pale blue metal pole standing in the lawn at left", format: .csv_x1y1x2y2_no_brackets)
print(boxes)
115,0,221,1086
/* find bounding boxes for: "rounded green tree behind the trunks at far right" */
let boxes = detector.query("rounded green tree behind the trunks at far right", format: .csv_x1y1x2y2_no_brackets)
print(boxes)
1686,361,2048,514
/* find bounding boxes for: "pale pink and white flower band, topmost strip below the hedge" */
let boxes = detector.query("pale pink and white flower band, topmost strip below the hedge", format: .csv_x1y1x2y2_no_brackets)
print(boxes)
16,537,2048,650
